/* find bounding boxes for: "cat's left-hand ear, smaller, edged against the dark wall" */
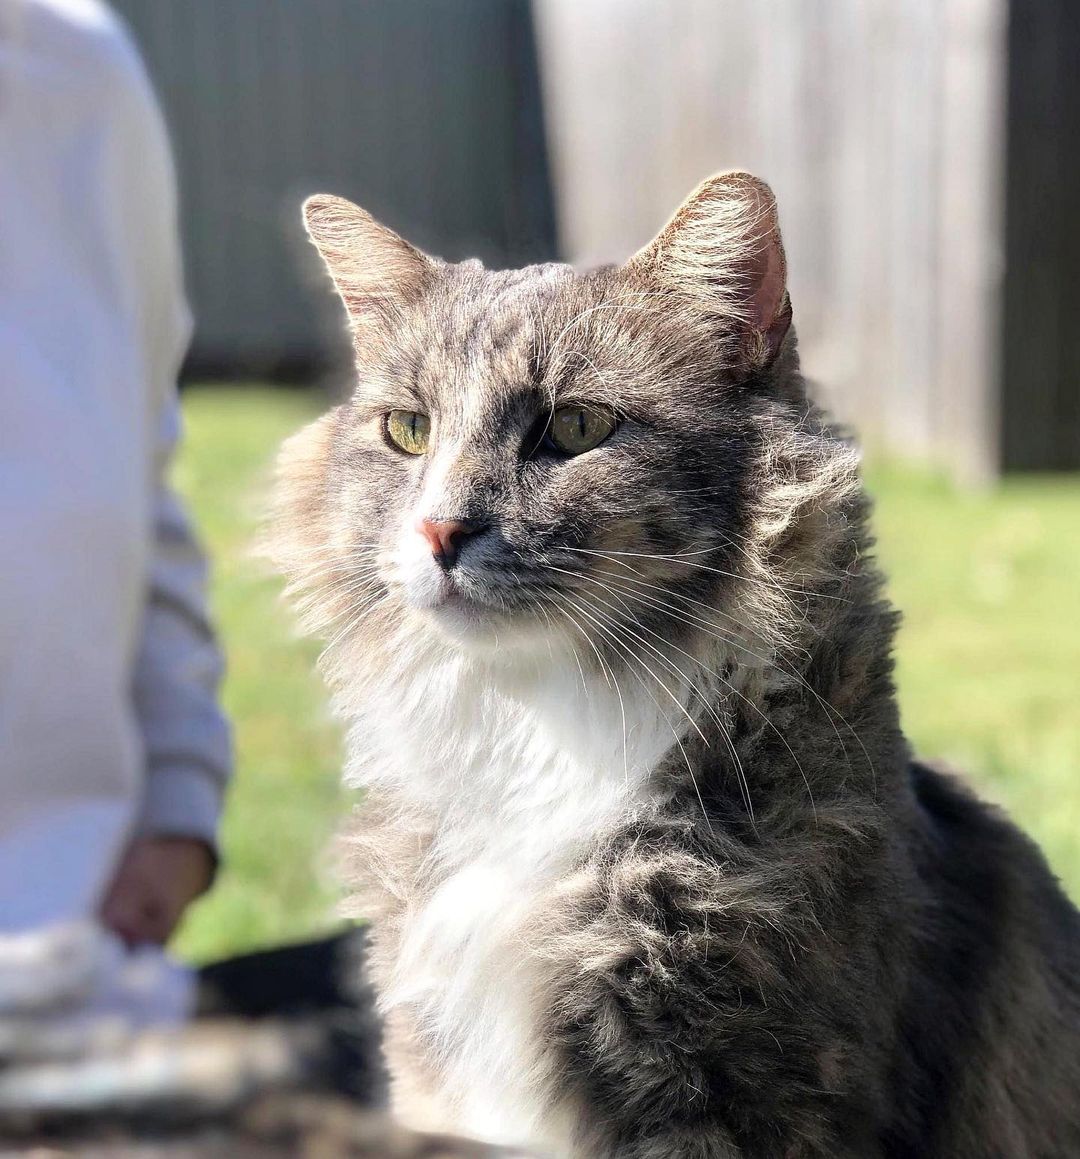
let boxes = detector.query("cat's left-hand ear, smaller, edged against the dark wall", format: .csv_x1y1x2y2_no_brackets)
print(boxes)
304,194,436,328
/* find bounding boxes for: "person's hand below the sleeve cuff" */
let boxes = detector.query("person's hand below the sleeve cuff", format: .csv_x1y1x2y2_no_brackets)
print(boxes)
101,837,214,946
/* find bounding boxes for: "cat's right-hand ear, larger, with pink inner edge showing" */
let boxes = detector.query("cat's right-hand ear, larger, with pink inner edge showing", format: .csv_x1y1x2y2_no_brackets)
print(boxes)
629,172,791,369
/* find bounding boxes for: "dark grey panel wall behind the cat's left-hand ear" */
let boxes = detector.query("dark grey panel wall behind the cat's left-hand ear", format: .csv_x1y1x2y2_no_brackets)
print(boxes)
116,0,554,374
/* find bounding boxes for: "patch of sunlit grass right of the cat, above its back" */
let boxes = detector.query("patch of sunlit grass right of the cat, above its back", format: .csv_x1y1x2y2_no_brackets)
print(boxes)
869,458,1080,885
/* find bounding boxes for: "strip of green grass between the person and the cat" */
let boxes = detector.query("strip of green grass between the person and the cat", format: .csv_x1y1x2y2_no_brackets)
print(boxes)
175,388,344,961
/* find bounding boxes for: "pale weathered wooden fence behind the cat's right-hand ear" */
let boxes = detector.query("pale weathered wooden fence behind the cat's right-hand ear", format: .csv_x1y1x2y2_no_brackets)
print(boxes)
535,0,1007,478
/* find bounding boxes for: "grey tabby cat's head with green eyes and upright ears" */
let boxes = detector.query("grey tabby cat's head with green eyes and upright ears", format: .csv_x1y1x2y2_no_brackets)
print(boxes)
278,173,849,676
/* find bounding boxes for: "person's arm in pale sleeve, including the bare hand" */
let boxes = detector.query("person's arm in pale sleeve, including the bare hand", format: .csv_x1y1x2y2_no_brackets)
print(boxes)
95,9,231,942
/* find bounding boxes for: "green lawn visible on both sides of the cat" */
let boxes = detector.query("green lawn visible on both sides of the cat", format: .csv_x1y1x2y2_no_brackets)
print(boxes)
176,388,1080,960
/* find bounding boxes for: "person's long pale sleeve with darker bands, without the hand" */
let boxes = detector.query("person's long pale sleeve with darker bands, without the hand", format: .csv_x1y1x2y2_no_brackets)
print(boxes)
110,6,231,843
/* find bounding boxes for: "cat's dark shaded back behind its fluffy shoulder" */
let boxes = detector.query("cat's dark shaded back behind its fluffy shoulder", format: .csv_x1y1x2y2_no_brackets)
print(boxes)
888,763,1080,1159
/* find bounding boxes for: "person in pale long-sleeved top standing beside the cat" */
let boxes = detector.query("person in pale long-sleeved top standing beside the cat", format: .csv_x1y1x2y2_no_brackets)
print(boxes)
0,0,231,1038
